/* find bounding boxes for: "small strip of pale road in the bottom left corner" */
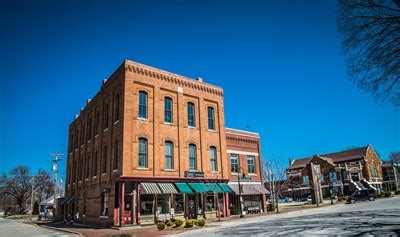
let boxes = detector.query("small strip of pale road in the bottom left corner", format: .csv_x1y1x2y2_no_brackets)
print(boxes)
0,218,77,237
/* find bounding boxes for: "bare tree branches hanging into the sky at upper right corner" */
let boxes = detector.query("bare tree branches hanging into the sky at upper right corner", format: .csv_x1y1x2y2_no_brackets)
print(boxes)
337,0,400,107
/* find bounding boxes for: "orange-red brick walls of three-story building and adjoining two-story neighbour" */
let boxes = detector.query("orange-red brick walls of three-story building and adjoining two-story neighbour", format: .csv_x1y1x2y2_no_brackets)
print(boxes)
64,60,262,226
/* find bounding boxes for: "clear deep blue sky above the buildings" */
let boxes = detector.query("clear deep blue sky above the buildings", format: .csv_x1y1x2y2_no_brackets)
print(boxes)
0,0,400,178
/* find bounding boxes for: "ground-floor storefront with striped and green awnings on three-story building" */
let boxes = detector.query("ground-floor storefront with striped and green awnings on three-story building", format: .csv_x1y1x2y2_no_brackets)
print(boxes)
115,181,233,225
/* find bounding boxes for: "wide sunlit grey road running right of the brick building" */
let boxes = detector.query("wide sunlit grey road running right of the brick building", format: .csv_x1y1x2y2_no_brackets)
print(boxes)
180,196,400,237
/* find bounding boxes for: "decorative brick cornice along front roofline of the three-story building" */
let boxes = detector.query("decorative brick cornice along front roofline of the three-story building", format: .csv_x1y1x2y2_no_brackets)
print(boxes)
125,60,223,96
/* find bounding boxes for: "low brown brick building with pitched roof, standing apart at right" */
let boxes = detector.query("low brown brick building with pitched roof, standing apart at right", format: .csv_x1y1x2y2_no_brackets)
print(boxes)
284,145,383,199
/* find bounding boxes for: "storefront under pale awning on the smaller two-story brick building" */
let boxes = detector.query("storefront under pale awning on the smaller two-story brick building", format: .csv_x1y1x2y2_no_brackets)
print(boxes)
229,182,269,214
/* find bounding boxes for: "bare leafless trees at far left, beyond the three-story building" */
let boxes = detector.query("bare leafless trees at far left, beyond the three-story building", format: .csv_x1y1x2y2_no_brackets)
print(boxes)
0,166,54,212
